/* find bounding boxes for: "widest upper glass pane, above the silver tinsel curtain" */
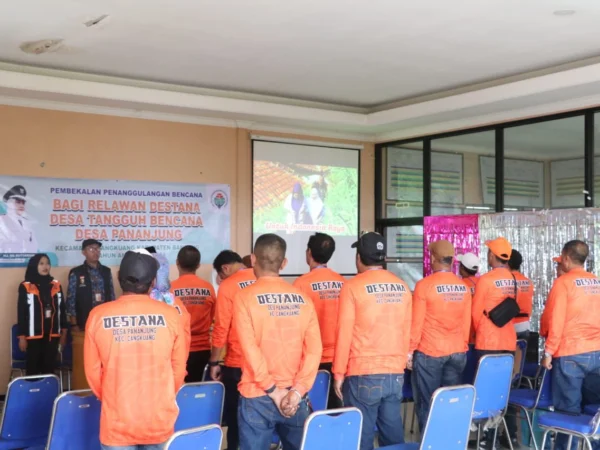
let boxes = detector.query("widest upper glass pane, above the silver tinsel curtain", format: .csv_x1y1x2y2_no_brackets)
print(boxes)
504,116,585,211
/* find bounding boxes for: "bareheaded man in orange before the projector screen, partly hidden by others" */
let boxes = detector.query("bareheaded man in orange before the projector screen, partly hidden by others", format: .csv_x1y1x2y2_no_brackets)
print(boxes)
294,233,345,409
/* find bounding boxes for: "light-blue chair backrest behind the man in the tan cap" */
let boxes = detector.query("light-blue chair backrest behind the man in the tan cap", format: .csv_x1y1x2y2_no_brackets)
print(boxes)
420,385,475,450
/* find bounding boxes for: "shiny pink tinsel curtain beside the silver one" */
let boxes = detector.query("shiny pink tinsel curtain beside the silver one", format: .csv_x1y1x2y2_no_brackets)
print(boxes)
423,214,479,276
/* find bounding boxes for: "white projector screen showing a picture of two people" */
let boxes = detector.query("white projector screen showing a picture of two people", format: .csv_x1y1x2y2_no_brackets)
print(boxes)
252,139,360,276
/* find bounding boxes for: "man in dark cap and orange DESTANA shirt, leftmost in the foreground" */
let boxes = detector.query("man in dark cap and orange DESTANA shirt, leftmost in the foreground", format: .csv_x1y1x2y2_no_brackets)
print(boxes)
84,250,187,450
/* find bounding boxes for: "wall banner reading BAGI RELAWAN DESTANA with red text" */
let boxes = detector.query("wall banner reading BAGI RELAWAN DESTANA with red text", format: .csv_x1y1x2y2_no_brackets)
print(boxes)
0,176,231,267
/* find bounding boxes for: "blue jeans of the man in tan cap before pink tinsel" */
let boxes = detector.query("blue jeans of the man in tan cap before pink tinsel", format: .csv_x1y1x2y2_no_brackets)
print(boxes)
412,352,467,433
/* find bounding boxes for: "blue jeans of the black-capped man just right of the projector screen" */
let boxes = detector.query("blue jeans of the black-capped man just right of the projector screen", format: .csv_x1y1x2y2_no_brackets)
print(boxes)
342,373,404,450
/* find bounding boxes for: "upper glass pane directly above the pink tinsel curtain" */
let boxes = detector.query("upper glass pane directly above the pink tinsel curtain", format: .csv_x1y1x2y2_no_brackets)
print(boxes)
431,131,496,216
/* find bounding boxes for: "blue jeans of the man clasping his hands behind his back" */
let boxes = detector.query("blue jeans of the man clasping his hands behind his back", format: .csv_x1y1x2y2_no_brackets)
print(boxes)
238,395,310,450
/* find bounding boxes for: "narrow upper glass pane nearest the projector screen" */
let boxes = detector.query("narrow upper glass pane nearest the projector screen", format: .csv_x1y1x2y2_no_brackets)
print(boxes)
382,142,423,219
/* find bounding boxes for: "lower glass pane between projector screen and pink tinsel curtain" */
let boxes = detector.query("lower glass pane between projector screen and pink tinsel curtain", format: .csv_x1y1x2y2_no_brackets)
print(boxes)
384,225,423,290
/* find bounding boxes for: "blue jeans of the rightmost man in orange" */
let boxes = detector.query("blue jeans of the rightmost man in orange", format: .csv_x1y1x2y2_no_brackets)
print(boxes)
552,351,600,450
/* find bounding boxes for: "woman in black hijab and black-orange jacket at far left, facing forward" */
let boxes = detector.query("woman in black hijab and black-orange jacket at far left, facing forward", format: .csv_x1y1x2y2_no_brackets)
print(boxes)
17,253,68,375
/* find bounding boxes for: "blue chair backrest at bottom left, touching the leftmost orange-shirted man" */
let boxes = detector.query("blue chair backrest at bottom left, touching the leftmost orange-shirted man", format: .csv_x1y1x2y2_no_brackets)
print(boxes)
47,390,101,450
